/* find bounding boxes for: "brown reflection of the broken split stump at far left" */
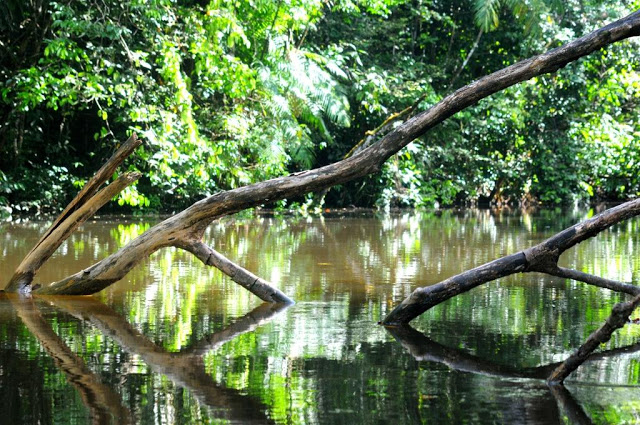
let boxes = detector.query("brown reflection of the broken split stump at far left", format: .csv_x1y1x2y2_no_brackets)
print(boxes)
10,297,132,424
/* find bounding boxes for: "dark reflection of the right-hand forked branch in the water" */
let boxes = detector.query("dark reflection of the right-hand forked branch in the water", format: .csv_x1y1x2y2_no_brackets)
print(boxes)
386,325,640,425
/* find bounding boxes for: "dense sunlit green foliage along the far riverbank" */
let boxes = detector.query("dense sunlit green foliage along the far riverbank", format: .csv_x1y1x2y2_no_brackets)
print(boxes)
0,0,640,212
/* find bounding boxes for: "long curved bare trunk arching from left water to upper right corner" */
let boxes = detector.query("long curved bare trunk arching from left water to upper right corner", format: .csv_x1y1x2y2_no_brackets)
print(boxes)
7,11,640,302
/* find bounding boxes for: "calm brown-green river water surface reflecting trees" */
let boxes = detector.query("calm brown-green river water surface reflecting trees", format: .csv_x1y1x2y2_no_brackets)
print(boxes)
0,210,640,425
